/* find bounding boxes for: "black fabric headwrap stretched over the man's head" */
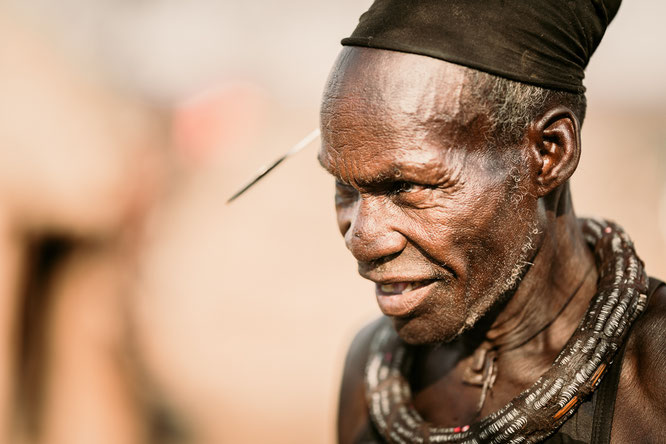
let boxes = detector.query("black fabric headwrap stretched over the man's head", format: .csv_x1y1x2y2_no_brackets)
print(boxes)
342,0,621,93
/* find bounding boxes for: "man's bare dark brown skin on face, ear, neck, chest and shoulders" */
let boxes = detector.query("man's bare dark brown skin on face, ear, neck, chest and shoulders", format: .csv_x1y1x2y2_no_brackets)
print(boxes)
319,48,666,443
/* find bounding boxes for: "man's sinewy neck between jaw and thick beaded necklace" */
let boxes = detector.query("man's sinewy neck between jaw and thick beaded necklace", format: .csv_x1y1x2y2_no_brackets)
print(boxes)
477,188,597,372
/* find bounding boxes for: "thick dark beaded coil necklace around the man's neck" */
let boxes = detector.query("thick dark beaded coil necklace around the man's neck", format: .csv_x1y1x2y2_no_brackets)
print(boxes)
365,219,647,444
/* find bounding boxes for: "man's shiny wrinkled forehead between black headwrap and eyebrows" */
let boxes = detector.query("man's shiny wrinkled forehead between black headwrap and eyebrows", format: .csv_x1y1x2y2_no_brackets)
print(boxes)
320,47,486,168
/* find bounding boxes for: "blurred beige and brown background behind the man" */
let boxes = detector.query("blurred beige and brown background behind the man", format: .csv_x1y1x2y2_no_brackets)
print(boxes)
0,0,666,444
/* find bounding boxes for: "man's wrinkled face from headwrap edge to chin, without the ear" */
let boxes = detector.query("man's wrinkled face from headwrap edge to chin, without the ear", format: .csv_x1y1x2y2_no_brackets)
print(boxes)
319,48,538,343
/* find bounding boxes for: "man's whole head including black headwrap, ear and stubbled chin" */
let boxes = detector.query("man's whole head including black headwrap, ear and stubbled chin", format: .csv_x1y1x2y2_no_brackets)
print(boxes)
319,0,620,343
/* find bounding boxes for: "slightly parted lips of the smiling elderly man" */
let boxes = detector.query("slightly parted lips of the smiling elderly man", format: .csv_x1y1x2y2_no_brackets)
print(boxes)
375,279,436,317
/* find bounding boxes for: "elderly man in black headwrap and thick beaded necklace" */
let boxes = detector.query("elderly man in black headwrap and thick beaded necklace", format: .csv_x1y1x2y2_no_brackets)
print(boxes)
319,0,666,443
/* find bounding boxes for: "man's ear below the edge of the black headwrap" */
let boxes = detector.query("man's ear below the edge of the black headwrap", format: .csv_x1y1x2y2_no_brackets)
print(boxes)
529,106,580,197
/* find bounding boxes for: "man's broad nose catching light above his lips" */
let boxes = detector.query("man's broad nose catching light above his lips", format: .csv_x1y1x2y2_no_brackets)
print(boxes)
344,196,407,262
